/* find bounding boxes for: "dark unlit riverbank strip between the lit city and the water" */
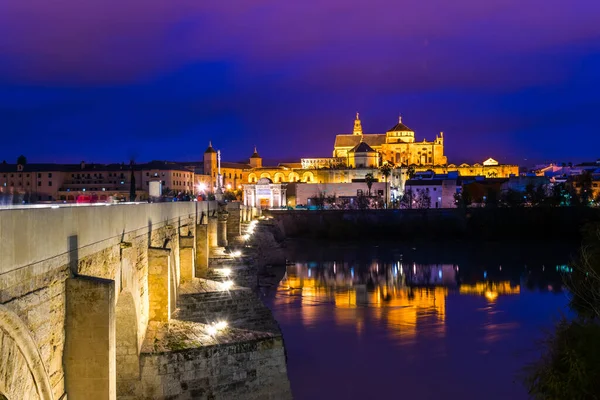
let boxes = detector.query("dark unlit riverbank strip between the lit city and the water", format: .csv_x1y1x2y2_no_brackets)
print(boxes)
265,207,600,241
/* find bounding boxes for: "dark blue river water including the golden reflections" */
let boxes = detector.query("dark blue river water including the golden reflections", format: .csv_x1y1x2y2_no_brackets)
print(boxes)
263,242,575,400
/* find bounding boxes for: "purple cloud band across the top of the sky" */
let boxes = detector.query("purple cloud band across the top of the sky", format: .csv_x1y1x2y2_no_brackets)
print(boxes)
0,0,600,84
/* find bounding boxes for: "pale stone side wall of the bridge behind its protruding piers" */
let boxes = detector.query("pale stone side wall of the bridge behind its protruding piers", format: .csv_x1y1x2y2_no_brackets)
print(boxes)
0,202,216,399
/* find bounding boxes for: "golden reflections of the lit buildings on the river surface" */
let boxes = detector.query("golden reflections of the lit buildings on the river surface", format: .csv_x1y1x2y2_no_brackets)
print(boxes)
274,261,521,343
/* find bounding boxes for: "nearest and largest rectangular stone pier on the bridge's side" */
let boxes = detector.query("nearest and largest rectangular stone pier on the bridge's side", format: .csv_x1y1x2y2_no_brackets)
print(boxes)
63,277,117,400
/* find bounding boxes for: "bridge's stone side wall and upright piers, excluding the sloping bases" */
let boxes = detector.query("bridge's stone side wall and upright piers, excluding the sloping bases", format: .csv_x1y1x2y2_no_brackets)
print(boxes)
0,202,285,400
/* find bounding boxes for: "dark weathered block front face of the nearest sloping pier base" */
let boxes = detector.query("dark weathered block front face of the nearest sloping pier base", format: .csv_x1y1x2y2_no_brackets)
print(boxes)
141,337,291,400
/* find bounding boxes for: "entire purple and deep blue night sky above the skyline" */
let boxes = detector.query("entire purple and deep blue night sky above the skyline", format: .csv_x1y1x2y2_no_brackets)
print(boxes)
0,0,600,163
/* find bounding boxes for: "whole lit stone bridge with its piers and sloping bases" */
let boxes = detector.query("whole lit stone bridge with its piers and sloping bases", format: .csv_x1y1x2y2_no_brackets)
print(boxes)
0,202,290,400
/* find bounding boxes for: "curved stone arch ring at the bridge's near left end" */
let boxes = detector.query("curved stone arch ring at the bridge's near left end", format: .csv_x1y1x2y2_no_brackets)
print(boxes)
0,305,54,400
